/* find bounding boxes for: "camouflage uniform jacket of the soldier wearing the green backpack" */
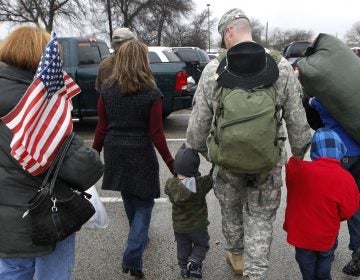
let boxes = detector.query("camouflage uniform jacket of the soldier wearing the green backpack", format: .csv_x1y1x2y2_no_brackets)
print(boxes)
186,52,311,165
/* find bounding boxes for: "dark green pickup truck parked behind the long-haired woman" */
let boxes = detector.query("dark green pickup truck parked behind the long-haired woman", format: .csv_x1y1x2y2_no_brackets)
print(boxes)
59,37,193,120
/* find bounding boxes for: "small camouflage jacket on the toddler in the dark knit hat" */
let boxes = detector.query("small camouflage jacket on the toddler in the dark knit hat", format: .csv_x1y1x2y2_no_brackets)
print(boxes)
165,175,213,233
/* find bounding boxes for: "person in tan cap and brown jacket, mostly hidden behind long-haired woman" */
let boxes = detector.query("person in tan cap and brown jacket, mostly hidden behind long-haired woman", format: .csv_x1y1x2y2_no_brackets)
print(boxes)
95,27,136,93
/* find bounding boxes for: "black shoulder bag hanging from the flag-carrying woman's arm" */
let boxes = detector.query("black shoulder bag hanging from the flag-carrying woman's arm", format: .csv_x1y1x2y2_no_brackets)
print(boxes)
23,133,95,245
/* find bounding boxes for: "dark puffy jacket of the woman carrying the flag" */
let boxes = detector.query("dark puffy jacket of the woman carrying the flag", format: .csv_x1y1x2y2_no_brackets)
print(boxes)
0,62,103,258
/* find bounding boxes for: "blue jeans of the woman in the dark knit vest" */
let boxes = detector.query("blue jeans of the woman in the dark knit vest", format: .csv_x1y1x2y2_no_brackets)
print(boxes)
122,194,154,270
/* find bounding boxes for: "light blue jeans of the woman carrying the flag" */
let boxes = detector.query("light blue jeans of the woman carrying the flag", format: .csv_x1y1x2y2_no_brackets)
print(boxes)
0,234,75,280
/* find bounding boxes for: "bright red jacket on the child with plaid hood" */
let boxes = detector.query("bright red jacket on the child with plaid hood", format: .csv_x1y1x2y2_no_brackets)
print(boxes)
283,157,359,252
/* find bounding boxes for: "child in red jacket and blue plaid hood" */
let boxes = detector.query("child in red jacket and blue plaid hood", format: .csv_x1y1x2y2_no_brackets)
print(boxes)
284,128,359,280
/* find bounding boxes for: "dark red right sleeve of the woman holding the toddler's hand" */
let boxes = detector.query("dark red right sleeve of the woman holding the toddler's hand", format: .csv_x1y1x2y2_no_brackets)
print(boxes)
149,99,174,174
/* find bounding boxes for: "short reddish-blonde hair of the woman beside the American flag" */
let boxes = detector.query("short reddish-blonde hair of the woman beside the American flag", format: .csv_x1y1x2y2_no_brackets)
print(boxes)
0,26,50,71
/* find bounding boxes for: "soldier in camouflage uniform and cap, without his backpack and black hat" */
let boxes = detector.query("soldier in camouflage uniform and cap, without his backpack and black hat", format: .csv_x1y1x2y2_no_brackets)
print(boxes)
186,9,311,280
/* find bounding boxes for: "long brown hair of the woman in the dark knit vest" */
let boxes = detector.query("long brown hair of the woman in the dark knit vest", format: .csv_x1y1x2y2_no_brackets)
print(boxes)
109,40,155,95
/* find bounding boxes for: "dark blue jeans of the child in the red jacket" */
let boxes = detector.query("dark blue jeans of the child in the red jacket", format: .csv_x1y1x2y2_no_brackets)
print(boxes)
295,247,332,280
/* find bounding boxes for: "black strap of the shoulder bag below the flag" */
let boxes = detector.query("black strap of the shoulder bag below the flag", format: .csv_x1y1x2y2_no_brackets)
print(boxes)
41,132,75,194
